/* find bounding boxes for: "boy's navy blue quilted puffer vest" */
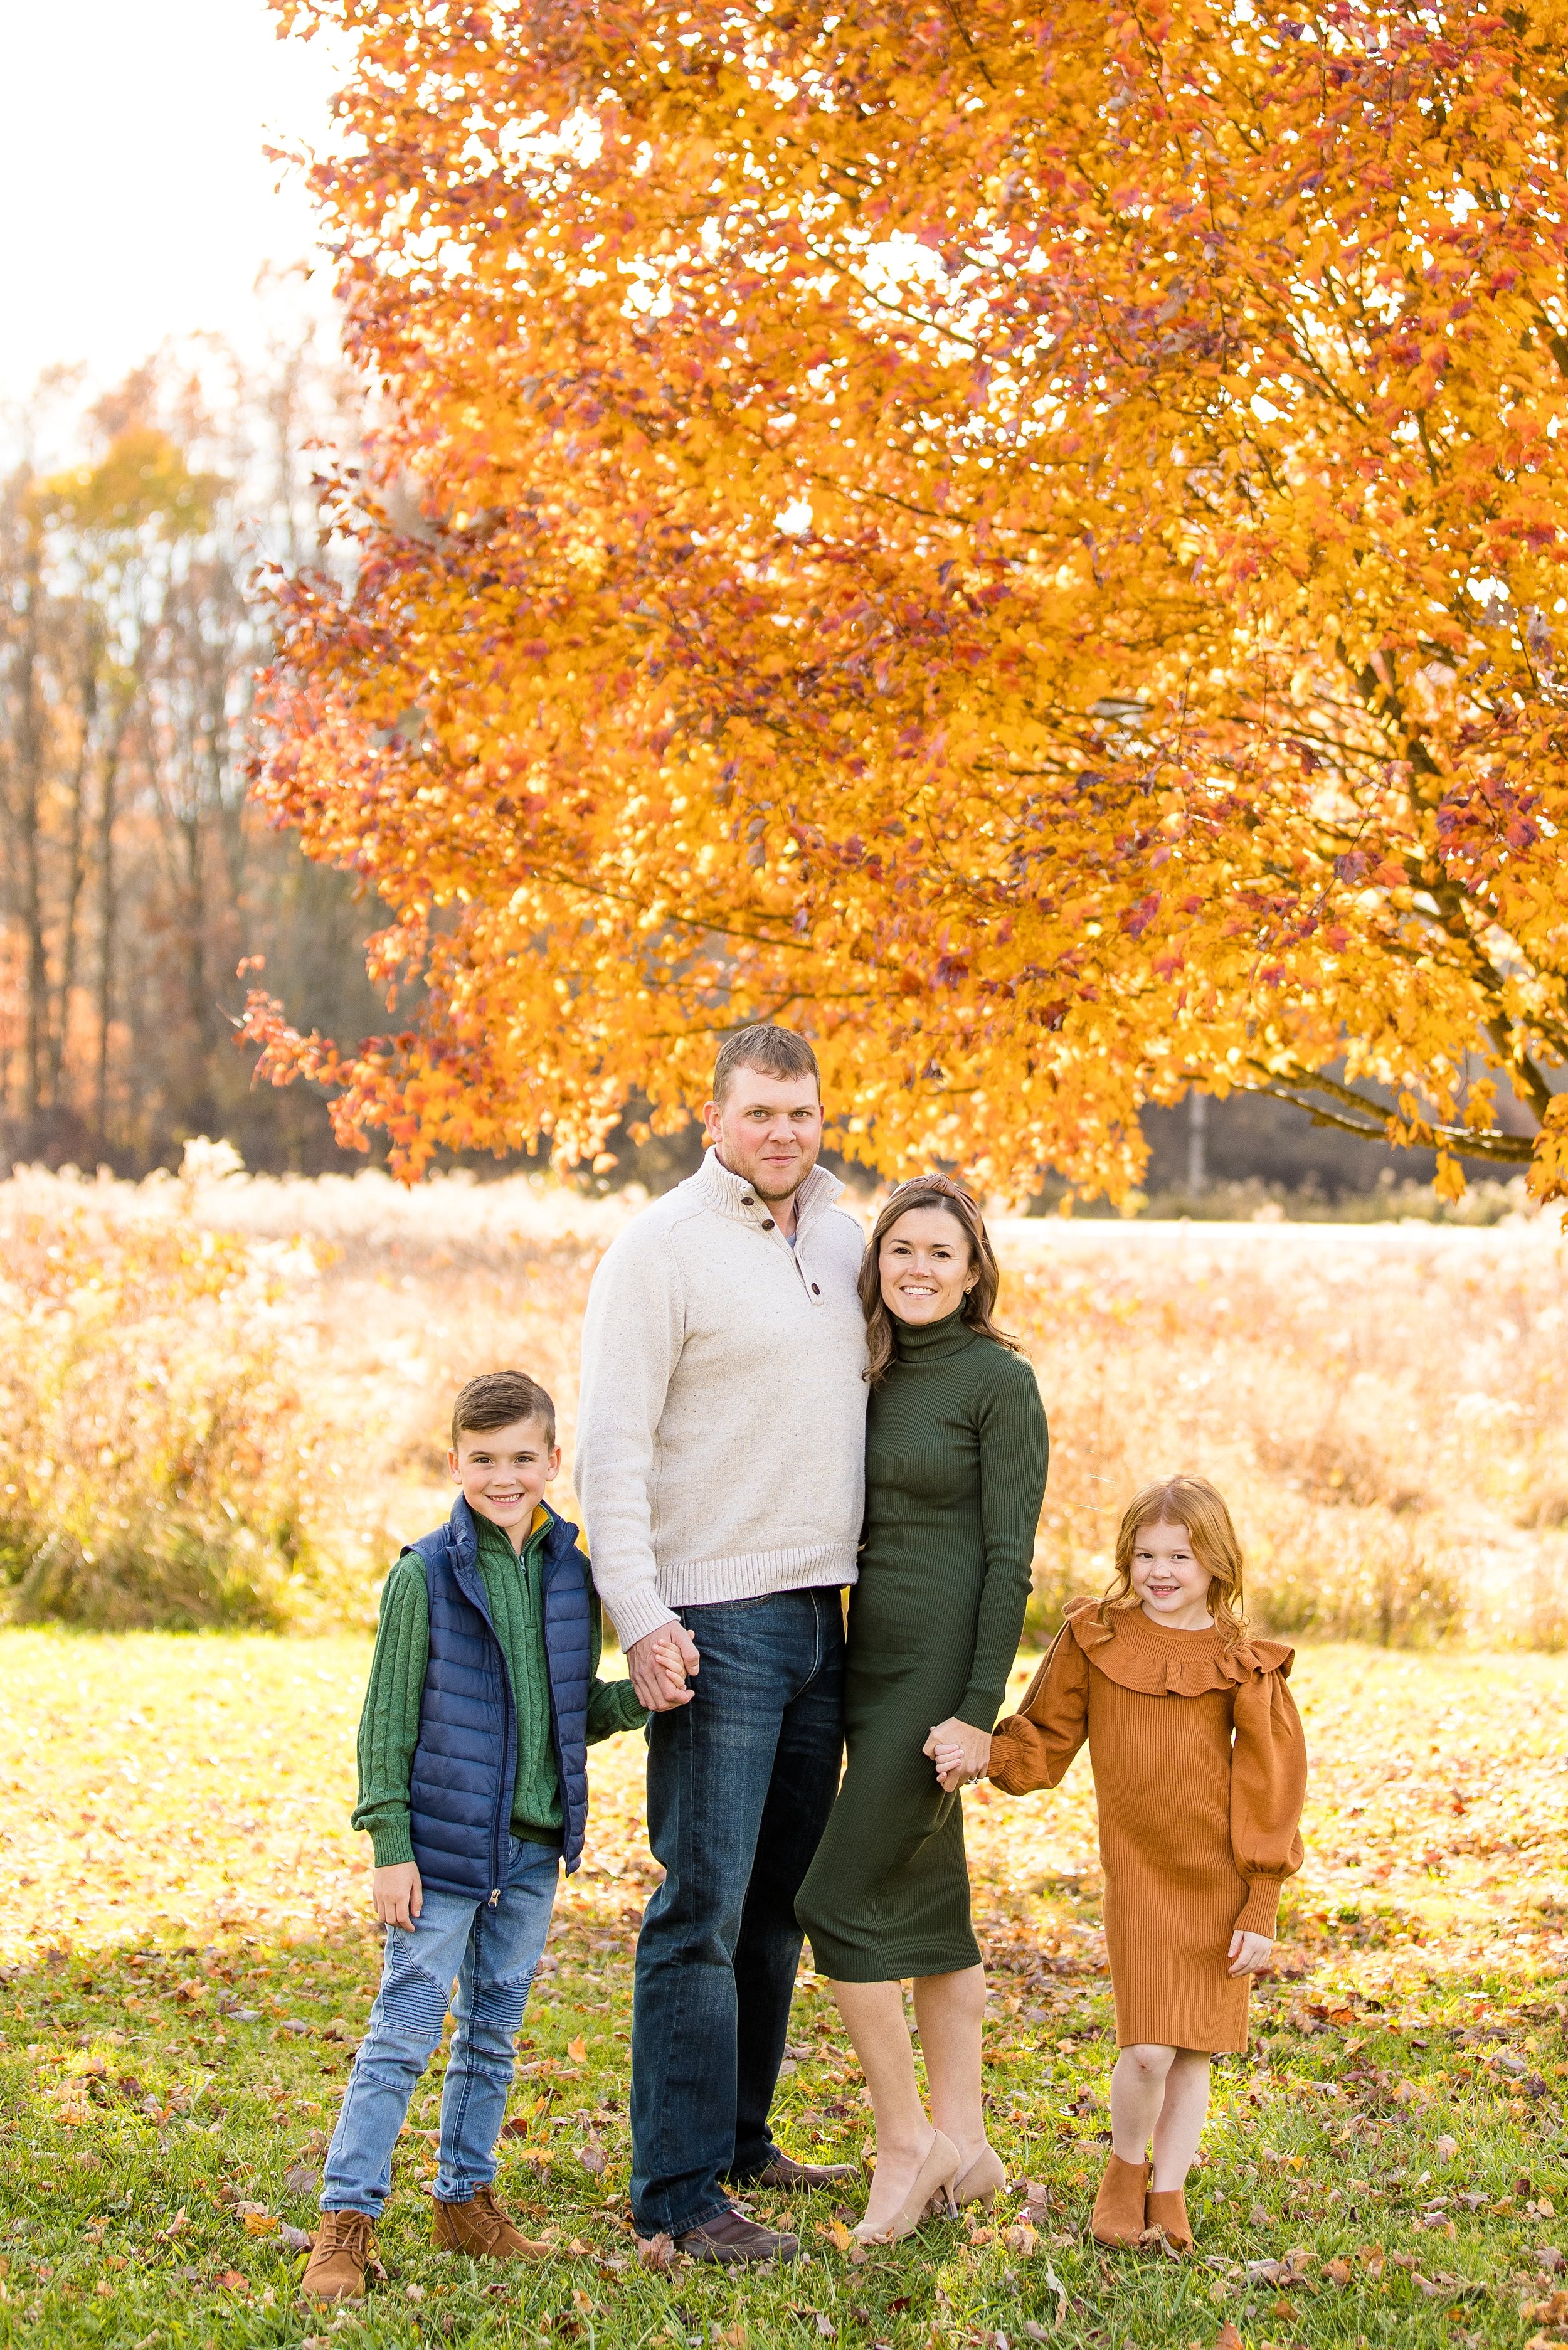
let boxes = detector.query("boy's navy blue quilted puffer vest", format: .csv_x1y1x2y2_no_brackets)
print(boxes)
409,1495,593,1901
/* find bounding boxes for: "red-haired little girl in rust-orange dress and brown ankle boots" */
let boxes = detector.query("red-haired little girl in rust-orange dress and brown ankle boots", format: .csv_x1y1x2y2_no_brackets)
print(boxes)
987,1476,1307,2252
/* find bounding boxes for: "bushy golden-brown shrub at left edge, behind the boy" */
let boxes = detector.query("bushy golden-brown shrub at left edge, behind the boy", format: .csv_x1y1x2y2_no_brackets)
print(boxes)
0,1151,329,1629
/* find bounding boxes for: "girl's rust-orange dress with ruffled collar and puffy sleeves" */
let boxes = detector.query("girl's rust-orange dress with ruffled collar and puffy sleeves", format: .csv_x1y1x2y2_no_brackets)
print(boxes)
990,1601,1307,2054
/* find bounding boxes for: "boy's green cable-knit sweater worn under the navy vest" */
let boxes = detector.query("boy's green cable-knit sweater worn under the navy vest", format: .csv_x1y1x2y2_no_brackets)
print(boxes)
352,1513,647,1868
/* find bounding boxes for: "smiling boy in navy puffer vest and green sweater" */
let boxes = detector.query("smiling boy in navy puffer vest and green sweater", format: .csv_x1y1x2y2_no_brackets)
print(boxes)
301,1370,647,2300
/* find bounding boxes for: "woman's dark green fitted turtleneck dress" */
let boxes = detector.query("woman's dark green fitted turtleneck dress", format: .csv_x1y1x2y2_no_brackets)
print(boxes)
795,1314,1046,1983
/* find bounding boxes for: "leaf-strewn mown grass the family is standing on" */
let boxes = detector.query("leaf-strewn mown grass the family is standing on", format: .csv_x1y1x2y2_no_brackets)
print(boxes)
0,1631,1568,2350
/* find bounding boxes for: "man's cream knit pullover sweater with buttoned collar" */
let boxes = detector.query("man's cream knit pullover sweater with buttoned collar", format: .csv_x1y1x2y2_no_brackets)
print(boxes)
574,1151,865,1649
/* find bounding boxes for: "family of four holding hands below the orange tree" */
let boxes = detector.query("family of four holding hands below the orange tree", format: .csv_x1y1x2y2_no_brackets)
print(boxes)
304,1027,1305,2299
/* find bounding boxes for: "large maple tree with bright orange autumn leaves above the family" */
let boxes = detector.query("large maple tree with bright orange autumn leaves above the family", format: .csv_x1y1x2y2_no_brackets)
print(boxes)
249,0,1568,1192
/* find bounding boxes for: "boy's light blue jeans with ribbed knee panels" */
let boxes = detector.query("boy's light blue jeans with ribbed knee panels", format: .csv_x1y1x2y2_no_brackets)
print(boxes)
322,1838,562,2218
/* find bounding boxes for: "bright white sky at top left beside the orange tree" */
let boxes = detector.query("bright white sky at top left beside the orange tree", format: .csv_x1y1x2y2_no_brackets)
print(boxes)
0,0,334,423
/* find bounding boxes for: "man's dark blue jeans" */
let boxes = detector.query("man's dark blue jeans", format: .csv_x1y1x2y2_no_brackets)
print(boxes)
632,1589,844,2235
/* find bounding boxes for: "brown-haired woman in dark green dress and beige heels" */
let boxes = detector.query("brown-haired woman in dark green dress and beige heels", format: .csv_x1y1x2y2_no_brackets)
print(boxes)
795,1175,1046,2242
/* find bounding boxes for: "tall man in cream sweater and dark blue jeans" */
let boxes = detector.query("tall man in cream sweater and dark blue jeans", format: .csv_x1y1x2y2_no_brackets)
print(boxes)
576,1027,865,2263
